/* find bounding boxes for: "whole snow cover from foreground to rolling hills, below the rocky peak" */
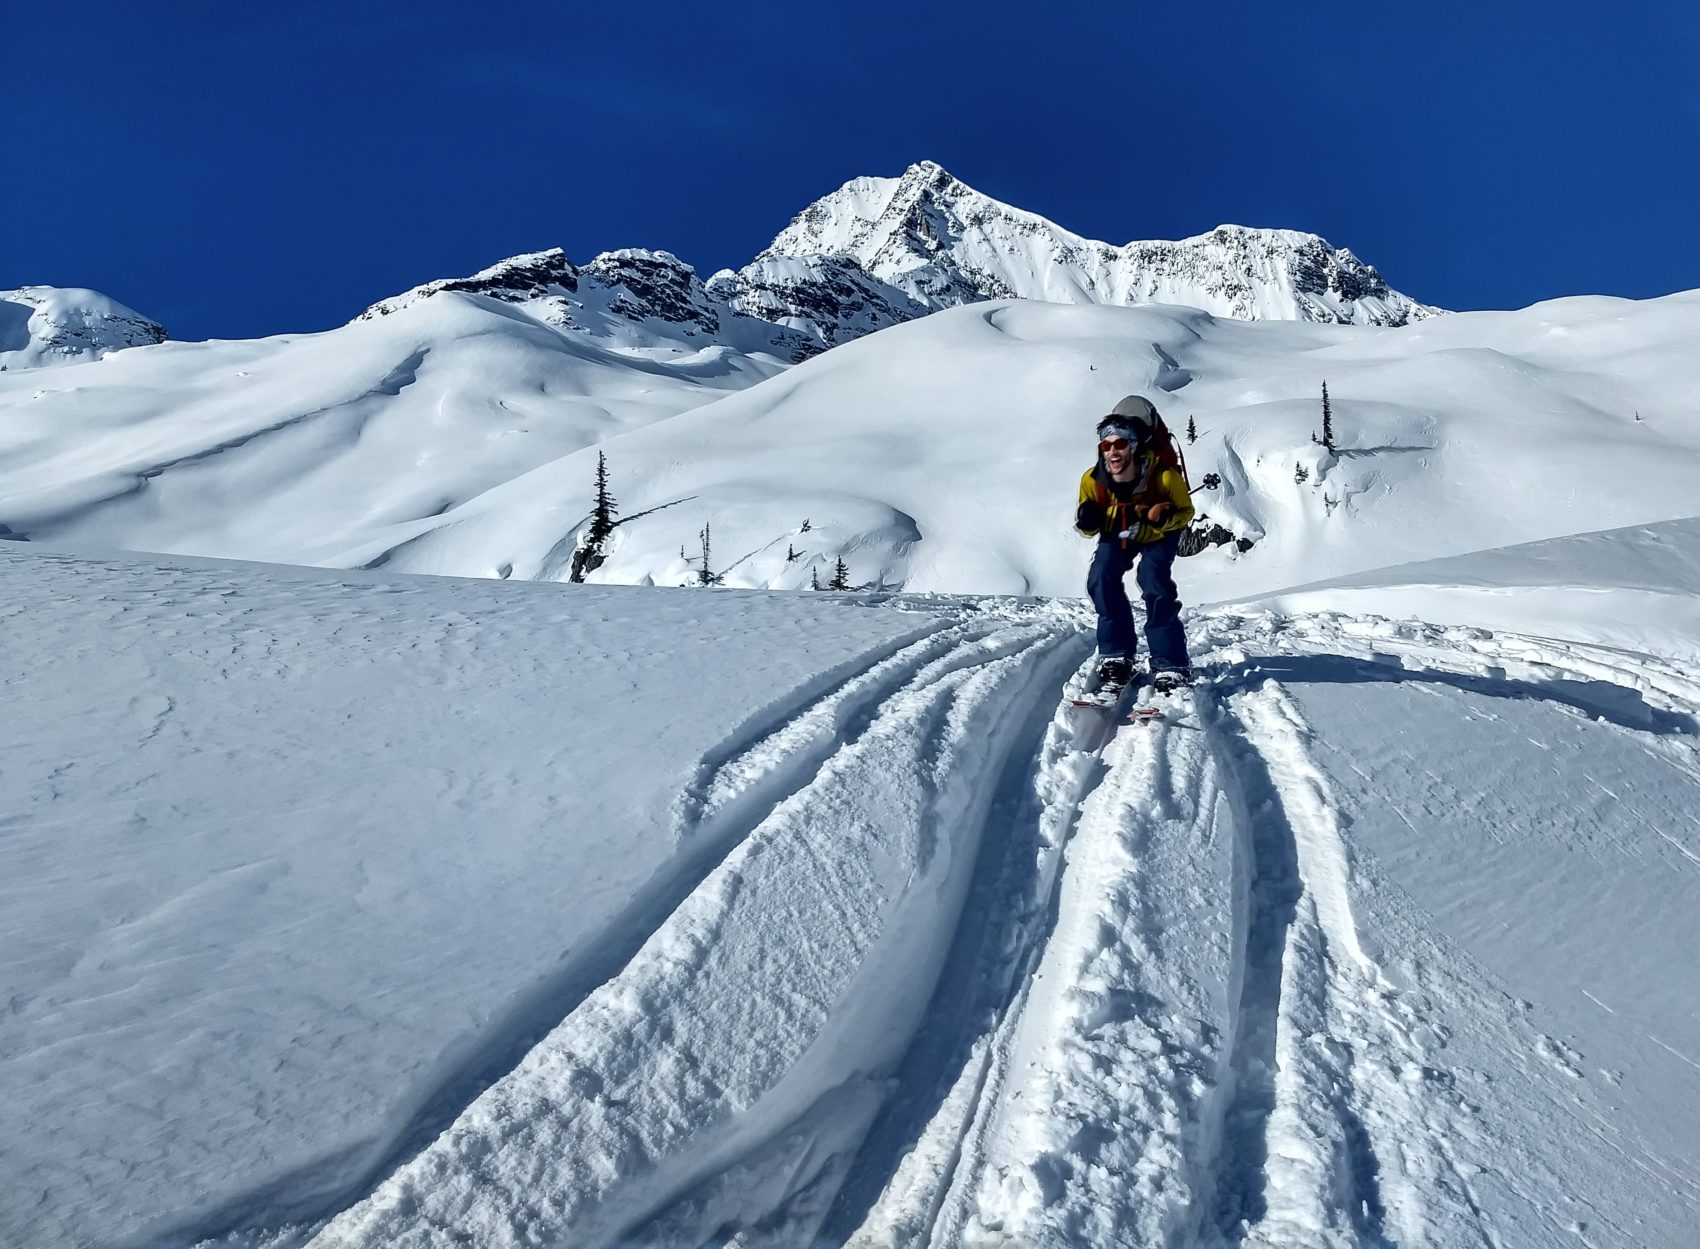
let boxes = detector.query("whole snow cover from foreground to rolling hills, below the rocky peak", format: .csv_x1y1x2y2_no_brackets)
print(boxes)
0,251,1700,1249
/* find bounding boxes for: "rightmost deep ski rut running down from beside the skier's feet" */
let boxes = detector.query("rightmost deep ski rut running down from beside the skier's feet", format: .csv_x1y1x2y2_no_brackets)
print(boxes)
1200,683,1491,1246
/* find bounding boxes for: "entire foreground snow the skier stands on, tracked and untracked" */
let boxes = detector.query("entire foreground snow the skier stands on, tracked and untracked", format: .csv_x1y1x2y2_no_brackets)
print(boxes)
0,540,1700,1249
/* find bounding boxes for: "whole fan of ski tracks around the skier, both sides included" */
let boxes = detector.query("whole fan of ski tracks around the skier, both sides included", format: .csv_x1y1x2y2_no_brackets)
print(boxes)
226,610,1700,1249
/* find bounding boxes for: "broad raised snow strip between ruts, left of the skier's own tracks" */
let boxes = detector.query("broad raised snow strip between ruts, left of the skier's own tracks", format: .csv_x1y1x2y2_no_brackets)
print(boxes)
313,611,1074,1249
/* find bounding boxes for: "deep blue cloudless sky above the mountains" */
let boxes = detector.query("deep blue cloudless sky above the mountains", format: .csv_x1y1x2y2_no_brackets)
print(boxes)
0,0,1700,338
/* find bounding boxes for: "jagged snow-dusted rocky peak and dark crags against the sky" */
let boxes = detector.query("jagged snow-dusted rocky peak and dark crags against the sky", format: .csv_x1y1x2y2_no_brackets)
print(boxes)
366,161,1442,360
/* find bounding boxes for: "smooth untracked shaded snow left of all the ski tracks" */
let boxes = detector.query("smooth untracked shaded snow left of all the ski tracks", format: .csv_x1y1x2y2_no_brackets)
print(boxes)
0,549,945,1246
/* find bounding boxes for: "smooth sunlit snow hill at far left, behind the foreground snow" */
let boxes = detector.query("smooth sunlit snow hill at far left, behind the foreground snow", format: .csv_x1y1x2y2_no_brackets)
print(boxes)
0,292,782,564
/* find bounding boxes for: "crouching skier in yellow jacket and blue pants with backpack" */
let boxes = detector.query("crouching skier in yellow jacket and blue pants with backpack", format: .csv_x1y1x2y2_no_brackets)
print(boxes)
1074,394,1193,695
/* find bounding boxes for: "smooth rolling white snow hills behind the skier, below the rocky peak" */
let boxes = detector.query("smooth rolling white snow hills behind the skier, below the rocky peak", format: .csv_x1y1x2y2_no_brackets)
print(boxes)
0,289,1700,603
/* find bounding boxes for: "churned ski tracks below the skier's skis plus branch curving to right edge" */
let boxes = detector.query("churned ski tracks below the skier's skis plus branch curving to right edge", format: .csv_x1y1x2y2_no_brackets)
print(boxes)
835,617,1700,1249
